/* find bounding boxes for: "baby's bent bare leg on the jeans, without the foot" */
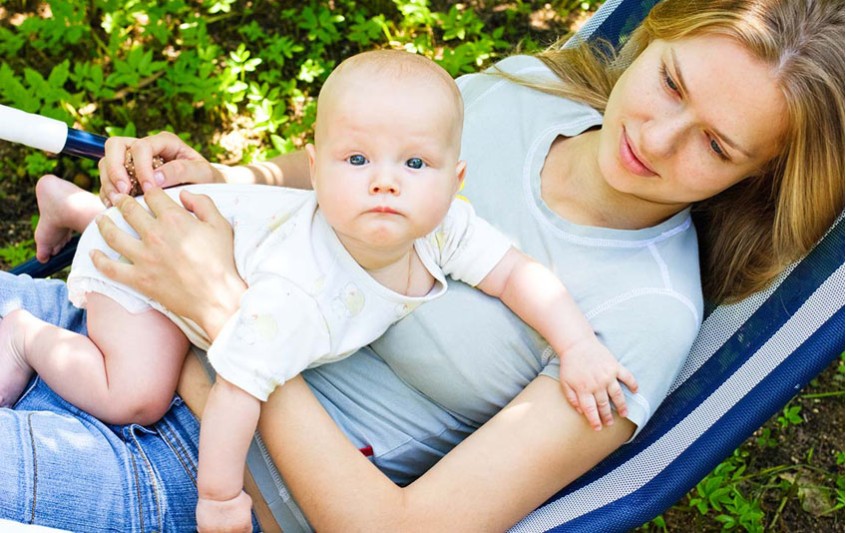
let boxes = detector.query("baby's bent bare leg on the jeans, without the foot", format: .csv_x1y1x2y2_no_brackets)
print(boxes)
16,293,188,425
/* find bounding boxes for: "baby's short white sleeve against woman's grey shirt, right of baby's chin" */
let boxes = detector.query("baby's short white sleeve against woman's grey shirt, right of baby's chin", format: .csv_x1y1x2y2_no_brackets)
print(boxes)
426,200,511,286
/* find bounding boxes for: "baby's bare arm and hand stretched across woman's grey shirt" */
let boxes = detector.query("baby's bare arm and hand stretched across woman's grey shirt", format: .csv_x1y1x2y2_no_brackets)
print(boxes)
478,247,637,430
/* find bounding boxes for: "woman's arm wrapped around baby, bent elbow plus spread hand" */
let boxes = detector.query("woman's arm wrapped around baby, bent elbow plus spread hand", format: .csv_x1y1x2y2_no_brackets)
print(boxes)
95,182,634,530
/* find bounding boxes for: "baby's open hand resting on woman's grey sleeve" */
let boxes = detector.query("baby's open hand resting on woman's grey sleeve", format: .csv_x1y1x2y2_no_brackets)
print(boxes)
560,336,637,431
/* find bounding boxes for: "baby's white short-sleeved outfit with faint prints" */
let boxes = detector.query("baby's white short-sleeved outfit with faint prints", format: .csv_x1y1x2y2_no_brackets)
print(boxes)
68,185,510,400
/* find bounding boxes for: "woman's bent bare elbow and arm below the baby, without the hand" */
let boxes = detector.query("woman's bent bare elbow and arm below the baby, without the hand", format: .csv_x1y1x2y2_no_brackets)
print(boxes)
259,376,634,531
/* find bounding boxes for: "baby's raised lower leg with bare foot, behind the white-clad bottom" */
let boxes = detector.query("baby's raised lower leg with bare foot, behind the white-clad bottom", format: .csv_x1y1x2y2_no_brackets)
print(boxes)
35,174,105,263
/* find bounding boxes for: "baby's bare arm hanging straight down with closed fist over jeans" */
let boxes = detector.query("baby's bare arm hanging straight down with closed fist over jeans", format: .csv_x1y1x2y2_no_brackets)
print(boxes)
197,376,261,532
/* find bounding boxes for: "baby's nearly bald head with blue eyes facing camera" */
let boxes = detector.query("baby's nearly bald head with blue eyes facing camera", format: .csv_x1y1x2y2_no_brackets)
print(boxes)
307,50,464,255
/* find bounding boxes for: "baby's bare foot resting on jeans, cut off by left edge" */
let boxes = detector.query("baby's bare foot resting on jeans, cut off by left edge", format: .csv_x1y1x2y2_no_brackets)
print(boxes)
0,310,34,407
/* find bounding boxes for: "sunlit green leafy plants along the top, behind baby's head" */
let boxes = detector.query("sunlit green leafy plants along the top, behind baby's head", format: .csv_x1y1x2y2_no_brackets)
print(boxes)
0,0,580,167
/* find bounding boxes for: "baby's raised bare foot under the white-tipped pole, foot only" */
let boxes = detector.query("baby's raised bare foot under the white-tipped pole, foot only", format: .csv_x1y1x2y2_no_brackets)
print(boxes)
35,175,79,263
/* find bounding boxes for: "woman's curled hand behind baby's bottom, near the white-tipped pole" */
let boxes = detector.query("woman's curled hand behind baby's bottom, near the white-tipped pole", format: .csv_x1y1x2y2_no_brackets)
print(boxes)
99,132,224,206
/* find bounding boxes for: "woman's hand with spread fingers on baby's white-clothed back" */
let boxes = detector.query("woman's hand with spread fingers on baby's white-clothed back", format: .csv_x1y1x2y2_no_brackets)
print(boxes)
91,188,246,339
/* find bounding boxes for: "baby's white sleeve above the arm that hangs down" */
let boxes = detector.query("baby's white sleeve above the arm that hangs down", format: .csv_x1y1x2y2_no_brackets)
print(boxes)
208,274,331,401
